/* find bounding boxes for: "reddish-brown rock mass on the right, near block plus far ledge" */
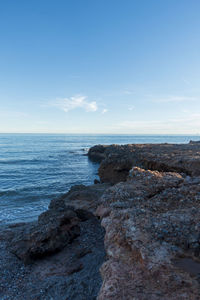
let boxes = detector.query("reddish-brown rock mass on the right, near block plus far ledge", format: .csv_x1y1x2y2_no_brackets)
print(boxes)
88,142,200,300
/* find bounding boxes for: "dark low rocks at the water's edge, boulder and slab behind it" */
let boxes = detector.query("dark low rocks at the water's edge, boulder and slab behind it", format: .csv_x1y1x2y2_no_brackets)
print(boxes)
10,184,109,263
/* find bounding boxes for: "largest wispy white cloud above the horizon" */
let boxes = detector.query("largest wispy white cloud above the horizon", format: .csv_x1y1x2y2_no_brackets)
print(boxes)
51,95,98,112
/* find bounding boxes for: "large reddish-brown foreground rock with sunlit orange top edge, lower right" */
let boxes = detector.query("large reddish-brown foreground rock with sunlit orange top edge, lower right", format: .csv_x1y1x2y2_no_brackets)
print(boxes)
96,167,200,300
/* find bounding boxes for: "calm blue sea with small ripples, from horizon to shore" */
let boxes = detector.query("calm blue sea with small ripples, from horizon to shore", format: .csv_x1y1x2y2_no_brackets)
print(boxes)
0,134,200,224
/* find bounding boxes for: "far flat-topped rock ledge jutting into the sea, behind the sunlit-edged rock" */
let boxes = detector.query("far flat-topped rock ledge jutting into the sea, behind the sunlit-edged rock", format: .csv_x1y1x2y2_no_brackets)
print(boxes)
88,142,200,183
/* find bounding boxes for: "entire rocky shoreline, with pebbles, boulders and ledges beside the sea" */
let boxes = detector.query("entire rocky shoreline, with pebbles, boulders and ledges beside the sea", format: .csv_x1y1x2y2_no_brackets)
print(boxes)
0,142,200,300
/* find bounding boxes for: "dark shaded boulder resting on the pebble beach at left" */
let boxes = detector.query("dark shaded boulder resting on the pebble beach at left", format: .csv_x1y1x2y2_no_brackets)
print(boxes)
10,208,80,263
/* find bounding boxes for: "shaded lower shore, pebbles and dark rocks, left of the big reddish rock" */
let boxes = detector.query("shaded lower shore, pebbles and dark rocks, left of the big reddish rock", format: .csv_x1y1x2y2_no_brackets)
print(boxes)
0,184,109,300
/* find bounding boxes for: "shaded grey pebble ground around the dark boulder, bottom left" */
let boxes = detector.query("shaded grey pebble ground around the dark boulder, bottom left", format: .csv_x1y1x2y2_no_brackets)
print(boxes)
0,217,105,300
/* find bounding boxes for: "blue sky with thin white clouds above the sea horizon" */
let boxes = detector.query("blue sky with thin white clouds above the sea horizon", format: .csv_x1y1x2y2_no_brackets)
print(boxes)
0,0,200,134
